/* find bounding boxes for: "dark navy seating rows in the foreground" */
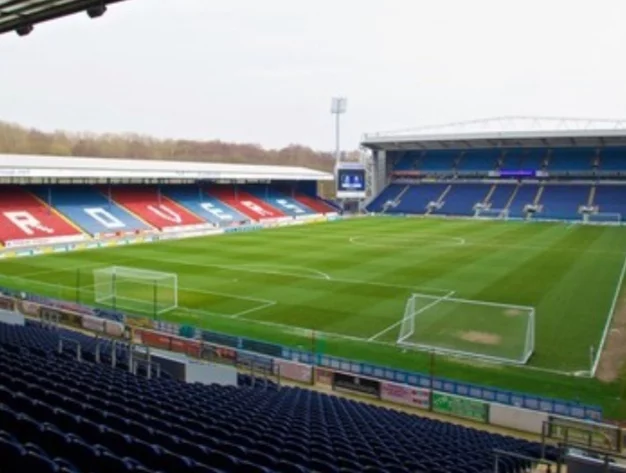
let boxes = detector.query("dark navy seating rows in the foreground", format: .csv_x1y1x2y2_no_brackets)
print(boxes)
0,318,557,473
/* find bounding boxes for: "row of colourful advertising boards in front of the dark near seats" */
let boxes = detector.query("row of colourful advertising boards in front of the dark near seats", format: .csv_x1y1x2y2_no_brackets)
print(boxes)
0,296,624,447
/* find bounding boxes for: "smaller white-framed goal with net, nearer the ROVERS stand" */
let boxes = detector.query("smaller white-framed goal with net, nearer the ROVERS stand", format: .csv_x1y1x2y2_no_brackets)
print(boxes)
93,266,178,315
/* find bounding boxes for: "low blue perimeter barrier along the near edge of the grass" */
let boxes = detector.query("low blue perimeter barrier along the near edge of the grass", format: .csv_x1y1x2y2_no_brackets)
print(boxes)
0,288,602,422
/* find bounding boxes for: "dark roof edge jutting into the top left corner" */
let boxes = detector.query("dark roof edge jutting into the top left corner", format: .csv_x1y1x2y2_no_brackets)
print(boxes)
0,0,123,35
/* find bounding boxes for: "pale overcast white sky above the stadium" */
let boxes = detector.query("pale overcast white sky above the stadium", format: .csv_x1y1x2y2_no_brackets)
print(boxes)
0,0,626,149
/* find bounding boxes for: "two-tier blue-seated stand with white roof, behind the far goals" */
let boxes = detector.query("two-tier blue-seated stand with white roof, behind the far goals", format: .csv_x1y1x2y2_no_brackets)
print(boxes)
362,117,626,223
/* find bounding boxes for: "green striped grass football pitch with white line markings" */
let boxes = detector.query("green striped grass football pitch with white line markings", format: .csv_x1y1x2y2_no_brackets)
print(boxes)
0,218,626,417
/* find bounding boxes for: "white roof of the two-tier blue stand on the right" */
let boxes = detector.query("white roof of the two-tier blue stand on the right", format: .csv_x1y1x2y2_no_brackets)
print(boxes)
362,117,626,150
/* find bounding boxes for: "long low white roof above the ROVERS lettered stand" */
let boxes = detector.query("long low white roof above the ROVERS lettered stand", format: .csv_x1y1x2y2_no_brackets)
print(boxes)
0,154,334,181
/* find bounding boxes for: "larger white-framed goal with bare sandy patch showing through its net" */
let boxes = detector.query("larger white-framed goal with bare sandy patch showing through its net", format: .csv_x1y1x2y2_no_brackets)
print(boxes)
397,294,535,364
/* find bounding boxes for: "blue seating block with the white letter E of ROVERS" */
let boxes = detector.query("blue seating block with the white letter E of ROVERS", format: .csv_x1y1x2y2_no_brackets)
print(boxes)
162,186,250,226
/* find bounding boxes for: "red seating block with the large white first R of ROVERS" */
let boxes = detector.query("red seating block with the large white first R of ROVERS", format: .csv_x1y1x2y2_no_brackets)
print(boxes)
0,186,82,244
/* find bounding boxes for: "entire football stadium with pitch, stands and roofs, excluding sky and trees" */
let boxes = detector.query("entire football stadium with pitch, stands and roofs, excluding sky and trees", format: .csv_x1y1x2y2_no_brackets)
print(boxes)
0,0,626,473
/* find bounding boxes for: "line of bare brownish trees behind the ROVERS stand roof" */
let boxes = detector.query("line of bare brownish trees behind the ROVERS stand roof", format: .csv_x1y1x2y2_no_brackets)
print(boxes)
0,121,358,172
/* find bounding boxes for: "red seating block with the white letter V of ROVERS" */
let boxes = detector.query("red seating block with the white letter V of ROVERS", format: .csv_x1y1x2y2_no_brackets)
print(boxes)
103,186,207,229
